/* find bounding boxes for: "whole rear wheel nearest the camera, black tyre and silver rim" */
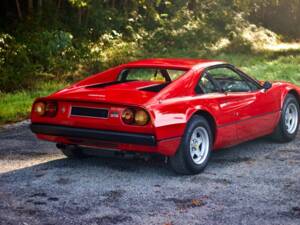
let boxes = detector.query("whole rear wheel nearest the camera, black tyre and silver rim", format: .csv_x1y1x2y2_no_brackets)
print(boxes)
169,115,213,174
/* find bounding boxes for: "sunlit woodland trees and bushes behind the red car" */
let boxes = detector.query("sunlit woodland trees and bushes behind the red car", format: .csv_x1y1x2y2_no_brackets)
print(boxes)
0,0,300,92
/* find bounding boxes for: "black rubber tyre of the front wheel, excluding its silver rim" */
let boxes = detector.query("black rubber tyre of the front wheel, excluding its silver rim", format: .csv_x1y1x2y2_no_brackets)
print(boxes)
271,94,300,142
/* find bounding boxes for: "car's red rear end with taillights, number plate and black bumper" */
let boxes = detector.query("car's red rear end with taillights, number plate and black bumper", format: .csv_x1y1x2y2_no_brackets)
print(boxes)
31,99,169,152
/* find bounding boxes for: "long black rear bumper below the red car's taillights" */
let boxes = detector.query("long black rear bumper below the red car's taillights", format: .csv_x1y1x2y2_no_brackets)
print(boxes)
30,123,156,146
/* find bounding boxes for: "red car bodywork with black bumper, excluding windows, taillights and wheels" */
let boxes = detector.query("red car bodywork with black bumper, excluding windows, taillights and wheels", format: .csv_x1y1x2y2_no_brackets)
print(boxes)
31,59,300,156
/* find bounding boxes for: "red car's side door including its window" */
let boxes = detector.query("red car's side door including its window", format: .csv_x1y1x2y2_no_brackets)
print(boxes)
207,65,277,142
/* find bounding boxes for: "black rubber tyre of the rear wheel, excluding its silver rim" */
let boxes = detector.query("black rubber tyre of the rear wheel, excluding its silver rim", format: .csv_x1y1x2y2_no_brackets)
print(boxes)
168,115,213,175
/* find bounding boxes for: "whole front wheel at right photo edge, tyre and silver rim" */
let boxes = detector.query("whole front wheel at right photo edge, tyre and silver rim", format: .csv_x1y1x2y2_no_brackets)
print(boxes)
272,94,300,142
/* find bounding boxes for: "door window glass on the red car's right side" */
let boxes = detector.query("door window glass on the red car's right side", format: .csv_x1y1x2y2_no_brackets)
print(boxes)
208,67,253,92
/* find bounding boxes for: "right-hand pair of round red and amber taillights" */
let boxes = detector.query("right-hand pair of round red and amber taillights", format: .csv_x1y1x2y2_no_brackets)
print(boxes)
122,108,150,126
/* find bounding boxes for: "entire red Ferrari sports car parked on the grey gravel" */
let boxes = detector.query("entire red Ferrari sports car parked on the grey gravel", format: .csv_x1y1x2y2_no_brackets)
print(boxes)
31,59,300,174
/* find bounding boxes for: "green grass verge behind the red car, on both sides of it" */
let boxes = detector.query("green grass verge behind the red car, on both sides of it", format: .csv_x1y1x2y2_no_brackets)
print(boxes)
0,51,300,124
